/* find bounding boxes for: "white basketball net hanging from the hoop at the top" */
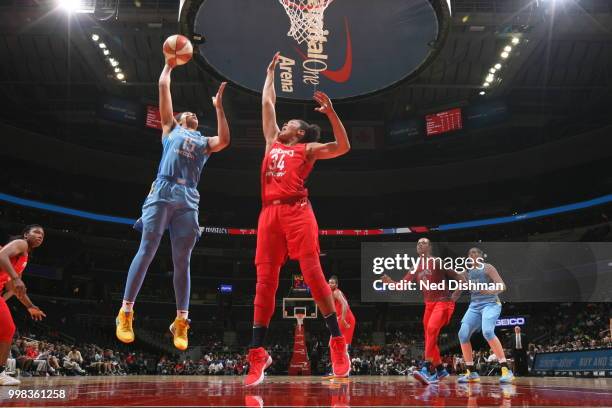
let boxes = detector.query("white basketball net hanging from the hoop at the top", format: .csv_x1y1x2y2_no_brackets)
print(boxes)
278,0,333,44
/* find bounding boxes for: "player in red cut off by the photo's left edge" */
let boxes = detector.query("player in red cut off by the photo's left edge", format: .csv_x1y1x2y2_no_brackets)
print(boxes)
0,225,46,385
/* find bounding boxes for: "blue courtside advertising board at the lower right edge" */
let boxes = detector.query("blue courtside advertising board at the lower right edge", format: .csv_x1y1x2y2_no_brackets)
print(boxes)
532,348,612,375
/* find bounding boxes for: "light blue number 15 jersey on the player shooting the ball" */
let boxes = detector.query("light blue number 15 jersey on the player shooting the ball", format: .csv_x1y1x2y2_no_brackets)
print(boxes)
157,125,210,187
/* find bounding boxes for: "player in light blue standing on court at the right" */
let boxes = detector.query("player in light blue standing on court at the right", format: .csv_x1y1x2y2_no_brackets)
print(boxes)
457,248,514,384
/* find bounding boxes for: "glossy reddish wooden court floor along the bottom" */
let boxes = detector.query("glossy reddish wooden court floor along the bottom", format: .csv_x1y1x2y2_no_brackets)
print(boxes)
0,376,612,407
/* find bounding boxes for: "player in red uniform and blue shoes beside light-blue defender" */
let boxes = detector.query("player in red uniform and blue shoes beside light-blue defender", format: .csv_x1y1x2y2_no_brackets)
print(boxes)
382,238,466,384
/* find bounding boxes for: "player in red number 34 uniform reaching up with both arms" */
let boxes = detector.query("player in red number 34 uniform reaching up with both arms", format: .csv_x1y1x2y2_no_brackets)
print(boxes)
245,53,350,386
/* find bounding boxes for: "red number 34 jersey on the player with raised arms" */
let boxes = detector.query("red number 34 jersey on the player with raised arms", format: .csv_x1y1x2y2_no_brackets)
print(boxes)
261,142,313,204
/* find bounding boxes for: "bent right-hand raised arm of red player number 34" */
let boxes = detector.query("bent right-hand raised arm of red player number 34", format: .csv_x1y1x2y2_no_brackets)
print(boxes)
308,91,351,160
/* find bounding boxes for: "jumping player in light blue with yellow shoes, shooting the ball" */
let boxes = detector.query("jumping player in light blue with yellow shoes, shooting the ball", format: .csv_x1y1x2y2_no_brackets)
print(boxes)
116,64,230,350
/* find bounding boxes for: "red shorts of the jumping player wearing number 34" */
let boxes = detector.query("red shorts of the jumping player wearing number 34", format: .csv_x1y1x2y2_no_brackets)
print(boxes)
255,200,320,264
